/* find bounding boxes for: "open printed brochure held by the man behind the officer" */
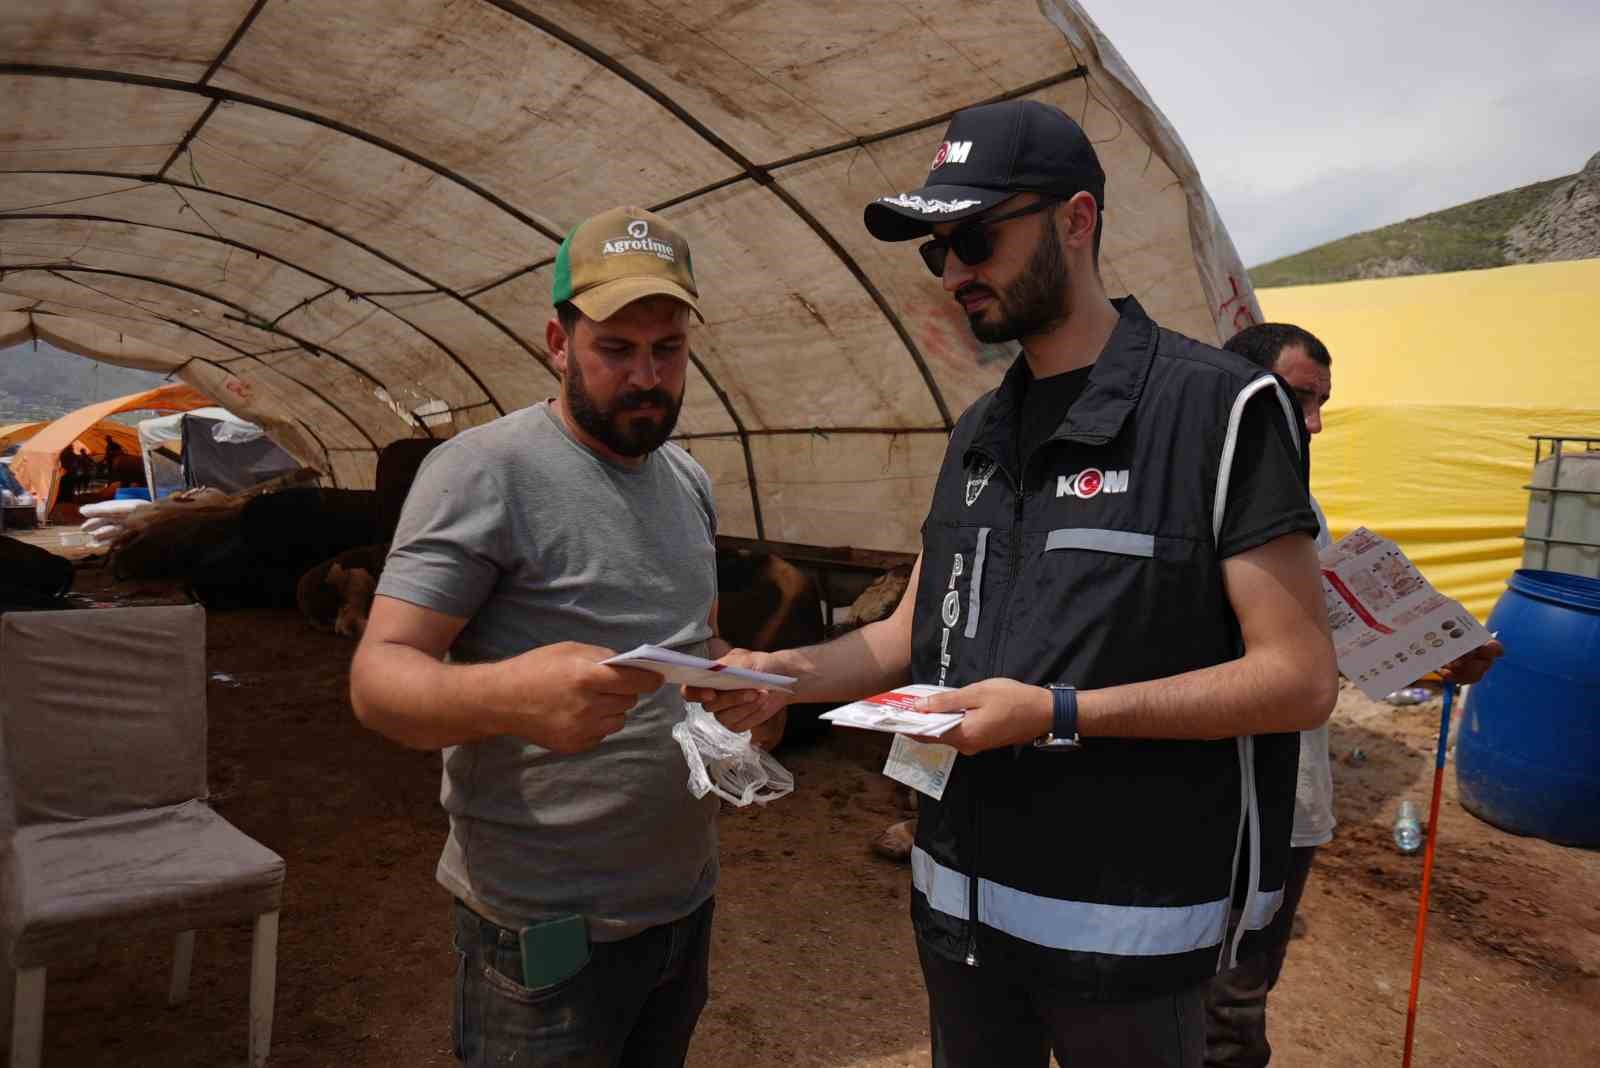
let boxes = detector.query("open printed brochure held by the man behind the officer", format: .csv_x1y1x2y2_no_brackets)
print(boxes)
1322,526,1491,699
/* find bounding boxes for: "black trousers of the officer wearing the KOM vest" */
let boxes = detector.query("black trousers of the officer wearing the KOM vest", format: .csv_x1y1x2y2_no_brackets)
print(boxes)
917,942,1205,1068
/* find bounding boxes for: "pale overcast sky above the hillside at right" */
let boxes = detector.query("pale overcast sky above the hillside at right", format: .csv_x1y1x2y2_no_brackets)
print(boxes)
1080,0,1600,265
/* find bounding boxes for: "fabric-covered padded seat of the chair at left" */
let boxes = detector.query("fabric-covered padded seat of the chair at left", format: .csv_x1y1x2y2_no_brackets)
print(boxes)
8,801,283,967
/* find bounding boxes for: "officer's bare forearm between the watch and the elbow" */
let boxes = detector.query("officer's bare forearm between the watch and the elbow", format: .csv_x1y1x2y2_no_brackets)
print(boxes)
1078,649,1339,739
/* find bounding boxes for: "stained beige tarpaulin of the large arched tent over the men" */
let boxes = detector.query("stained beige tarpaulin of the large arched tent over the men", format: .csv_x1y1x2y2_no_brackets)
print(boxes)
0,0,1256,550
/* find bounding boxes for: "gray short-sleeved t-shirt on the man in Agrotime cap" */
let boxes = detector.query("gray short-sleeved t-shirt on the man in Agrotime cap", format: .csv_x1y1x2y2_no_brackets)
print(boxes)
378,401,717,942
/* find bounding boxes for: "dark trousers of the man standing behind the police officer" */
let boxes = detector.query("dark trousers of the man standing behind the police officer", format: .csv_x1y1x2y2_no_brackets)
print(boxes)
1205,846,1317,1068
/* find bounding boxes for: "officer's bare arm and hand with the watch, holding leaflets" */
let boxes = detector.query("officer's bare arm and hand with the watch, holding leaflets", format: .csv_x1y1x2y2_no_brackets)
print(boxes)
925,534,1339,753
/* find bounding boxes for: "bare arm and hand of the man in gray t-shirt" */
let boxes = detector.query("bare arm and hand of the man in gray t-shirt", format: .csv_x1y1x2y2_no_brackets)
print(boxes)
350,596,661,753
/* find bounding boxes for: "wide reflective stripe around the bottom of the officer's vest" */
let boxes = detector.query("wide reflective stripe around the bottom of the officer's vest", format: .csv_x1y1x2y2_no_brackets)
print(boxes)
910,846,1283,956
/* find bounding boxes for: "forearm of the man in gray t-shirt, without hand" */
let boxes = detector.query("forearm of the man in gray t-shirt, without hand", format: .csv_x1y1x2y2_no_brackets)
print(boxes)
350,641,506,750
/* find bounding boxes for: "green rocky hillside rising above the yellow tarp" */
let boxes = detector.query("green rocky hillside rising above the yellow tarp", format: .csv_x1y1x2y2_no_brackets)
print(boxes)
1250,153,1600,289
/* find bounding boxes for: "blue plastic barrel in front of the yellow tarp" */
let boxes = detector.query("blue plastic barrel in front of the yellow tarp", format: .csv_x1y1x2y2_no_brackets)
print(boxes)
1456,571,1600,846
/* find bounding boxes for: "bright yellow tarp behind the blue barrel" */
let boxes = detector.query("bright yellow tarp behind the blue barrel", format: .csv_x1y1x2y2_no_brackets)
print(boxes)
1258,259,1600,619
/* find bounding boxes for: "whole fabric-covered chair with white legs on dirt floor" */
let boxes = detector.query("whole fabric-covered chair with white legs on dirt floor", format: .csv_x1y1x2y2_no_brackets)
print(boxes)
0,606,283,1068
